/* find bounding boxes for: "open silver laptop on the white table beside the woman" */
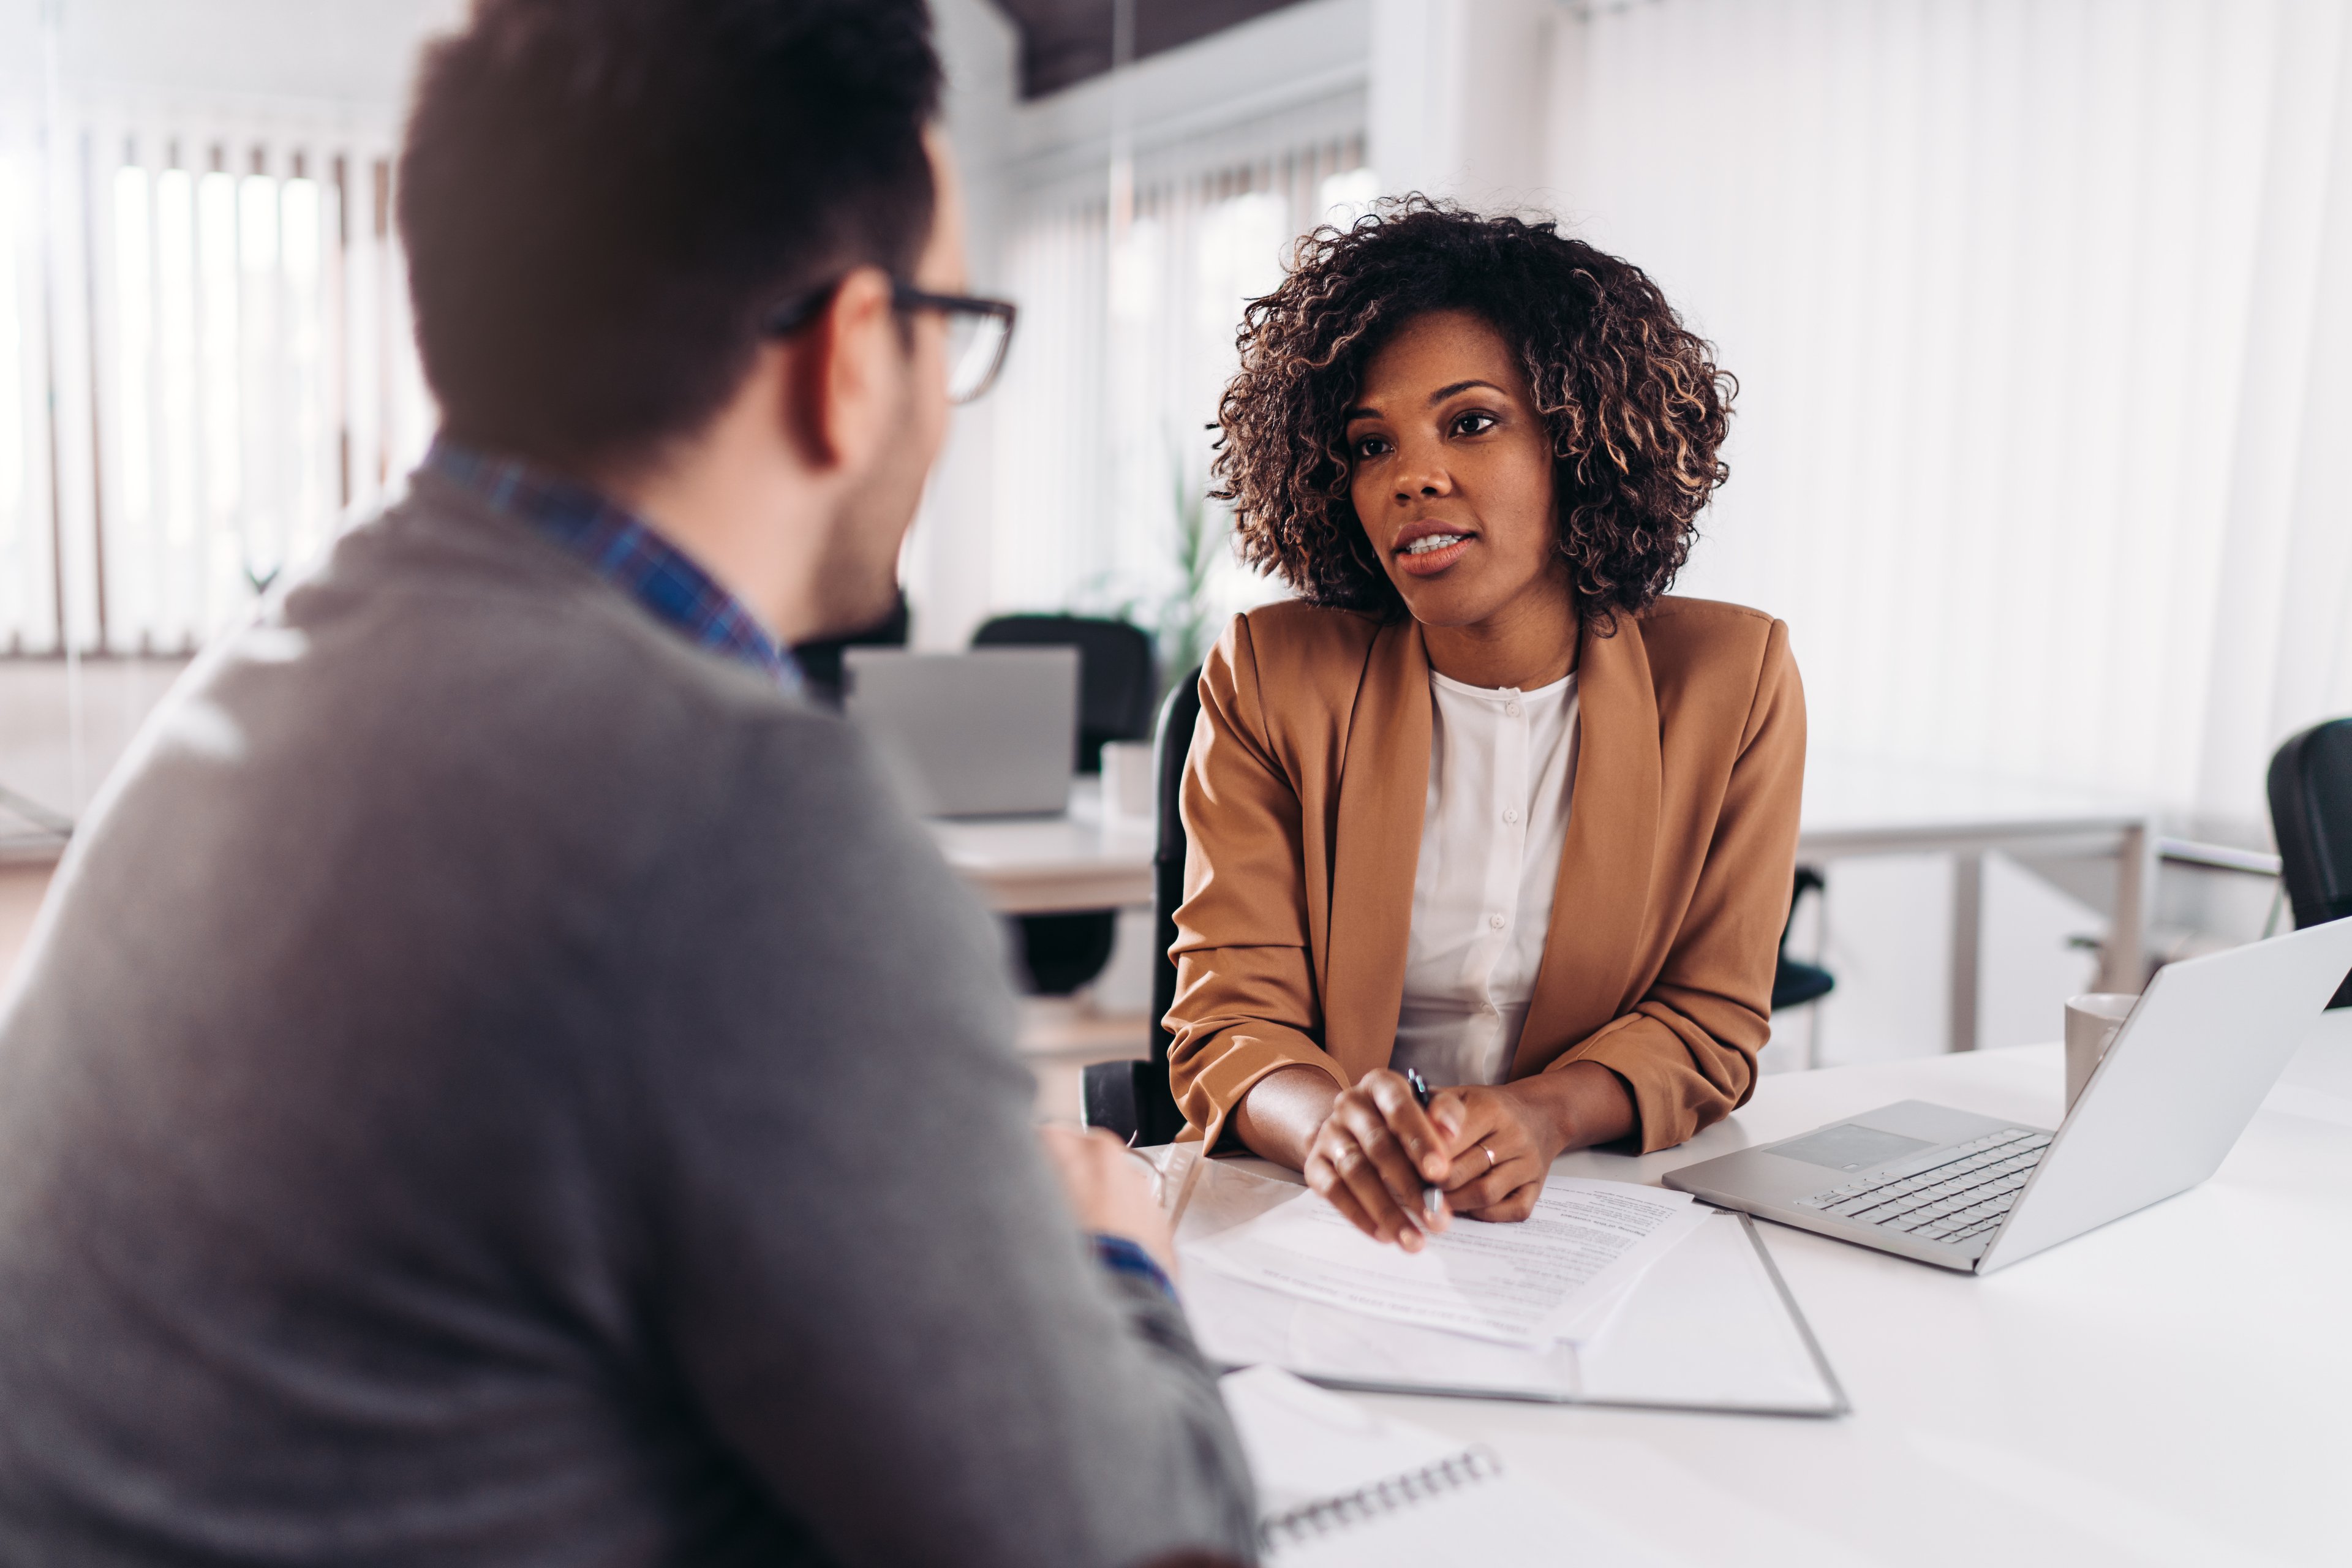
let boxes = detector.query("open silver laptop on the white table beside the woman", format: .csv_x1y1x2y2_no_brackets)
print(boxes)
1665,919,2352,1274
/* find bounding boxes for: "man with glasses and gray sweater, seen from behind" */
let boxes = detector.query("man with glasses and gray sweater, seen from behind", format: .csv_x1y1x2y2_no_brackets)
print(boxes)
0,0,1249,1563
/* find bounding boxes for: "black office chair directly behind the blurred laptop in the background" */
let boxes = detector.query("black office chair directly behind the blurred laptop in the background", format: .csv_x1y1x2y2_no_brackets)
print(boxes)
971,616,1157,997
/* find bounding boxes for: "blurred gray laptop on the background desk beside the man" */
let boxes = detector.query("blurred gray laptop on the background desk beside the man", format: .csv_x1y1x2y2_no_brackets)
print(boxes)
842,646,1077,816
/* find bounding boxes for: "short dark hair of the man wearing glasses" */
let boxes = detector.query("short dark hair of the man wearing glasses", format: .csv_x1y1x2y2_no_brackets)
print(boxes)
398,0,941,466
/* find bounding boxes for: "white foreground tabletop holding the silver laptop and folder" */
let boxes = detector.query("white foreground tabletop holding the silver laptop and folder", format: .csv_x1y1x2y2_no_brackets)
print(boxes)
1232,1011,2352,1568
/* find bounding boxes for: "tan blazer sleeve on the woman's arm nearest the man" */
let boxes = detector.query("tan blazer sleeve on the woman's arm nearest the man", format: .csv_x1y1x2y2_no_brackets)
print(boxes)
1167,618,1350,1128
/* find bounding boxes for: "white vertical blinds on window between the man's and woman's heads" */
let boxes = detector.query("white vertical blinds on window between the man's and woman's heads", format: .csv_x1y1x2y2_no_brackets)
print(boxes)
988,94,1371,661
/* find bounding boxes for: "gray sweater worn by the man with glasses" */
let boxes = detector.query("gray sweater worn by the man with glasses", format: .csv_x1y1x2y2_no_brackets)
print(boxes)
0,475,1249,1566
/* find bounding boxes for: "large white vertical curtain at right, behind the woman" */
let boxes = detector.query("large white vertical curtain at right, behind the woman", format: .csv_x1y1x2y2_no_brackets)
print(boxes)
1550,0,2352,835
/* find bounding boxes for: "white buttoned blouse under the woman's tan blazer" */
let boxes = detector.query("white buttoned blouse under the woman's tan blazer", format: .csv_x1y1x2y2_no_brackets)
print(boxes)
1390,670,1578,1084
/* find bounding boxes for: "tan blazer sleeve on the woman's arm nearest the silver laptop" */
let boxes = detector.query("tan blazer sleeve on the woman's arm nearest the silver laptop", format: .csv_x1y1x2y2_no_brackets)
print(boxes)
1548,620,1804,1154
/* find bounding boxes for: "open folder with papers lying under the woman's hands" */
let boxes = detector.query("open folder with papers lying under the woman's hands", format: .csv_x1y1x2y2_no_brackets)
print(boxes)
1171,1150,1846,1415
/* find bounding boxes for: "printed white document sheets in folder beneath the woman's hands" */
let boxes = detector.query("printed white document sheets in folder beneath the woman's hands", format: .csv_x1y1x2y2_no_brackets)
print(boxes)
1183,1178,1703,1344
